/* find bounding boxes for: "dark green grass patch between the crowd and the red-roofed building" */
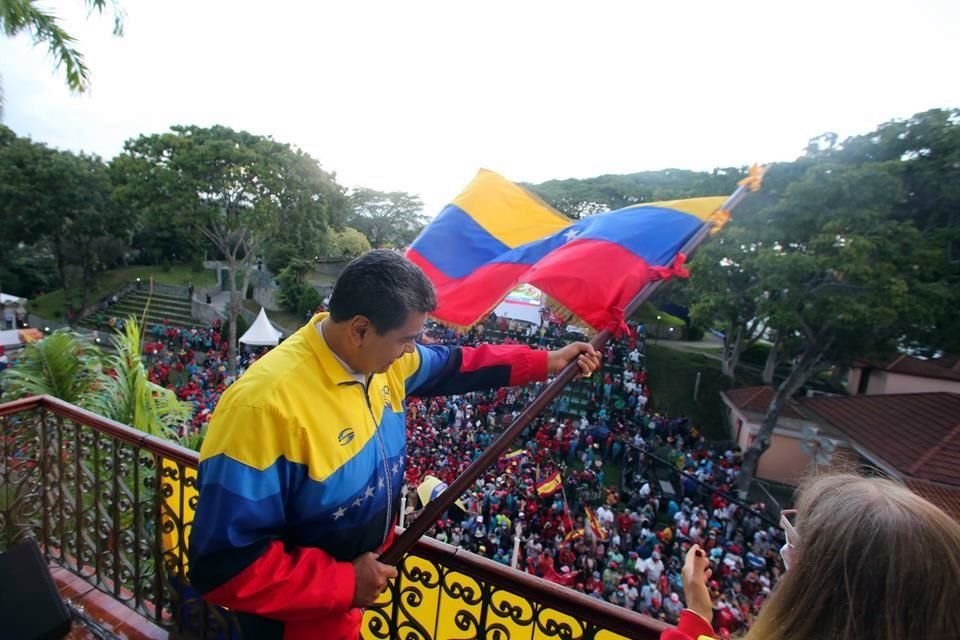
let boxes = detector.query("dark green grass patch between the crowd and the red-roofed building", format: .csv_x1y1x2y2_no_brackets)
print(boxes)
647,340,730,440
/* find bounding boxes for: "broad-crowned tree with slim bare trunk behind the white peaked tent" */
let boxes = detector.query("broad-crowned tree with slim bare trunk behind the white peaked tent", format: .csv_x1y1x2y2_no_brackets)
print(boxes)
112,126,341,376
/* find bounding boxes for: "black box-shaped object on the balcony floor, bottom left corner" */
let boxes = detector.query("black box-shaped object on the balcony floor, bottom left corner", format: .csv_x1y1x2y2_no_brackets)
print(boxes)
0,539,70,640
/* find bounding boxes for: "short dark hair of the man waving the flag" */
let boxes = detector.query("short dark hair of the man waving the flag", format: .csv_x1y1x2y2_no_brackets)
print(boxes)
330,249,437,335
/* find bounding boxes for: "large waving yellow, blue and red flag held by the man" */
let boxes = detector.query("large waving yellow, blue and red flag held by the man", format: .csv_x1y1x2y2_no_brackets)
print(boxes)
407,170,725,331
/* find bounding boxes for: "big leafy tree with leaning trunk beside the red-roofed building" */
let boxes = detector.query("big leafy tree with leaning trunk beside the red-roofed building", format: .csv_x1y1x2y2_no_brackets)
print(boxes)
737,161,947,492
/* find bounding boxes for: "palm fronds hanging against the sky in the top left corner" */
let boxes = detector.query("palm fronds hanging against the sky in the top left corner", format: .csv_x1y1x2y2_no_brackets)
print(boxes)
0,0,124,116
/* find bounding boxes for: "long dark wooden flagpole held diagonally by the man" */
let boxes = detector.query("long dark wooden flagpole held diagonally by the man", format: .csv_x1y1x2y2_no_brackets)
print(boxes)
380,166,763,564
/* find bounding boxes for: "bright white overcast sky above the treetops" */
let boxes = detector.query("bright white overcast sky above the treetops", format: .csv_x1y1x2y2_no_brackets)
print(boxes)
0,0,960,215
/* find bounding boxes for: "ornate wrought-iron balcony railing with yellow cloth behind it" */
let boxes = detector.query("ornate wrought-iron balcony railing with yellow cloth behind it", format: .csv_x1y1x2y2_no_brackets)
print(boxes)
0,396,665,640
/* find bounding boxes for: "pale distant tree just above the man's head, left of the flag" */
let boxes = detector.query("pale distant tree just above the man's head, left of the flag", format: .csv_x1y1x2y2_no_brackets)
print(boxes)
347,188,427,249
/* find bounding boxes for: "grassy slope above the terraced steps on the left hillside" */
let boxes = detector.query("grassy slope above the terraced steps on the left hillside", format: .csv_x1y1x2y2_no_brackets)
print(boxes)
27,265,217,320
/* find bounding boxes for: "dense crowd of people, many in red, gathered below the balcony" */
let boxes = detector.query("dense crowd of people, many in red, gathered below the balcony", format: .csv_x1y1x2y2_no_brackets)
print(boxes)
137,308,782,633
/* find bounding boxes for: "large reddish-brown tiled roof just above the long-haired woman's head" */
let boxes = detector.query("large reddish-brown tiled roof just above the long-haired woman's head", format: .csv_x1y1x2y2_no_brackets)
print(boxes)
800,393,960,488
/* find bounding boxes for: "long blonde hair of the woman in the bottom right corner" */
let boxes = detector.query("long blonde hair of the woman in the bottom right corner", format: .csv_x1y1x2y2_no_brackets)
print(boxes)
746,474,960,640
